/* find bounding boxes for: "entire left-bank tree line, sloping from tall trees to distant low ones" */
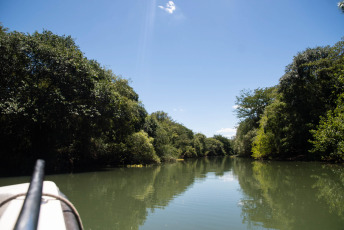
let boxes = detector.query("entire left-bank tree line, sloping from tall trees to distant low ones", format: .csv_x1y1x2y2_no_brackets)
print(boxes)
0,25,232,175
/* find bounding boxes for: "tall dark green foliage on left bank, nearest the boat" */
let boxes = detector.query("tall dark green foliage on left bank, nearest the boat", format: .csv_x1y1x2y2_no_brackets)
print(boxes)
0,27,147,171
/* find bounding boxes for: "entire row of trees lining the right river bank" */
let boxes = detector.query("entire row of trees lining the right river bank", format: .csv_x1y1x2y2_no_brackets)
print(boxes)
234,40,344,162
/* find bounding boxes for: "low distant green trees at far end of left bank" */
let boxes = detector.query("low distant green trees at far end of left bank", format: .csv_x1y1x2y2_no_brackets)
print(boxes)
143,111,227,161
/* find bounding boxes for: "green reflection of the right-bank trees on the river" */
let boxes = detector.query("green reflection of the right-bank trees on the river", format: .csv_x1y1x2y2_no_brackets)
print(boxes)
233,159,344,229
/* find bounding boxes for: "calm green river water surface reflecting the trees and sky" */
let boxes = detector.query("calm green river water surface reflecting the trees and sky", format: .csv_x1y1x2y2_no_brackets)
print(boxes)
0,158,344,230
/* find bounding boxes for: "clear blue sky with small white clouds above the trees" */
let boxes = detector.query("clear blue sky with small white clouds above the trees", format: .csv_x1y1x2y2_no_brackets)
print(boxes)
0,0,344,137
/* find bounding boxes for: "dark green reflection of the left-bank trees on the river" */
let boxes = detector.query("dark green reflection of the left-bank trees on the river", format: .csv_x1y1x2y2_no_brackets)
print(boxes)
47,158,231,229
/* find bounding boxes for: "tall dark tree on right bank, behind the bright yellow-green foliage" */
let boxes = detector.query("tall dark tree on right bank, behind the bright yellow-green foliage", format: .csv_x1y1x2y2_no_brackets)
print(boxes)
272,46,336,157
